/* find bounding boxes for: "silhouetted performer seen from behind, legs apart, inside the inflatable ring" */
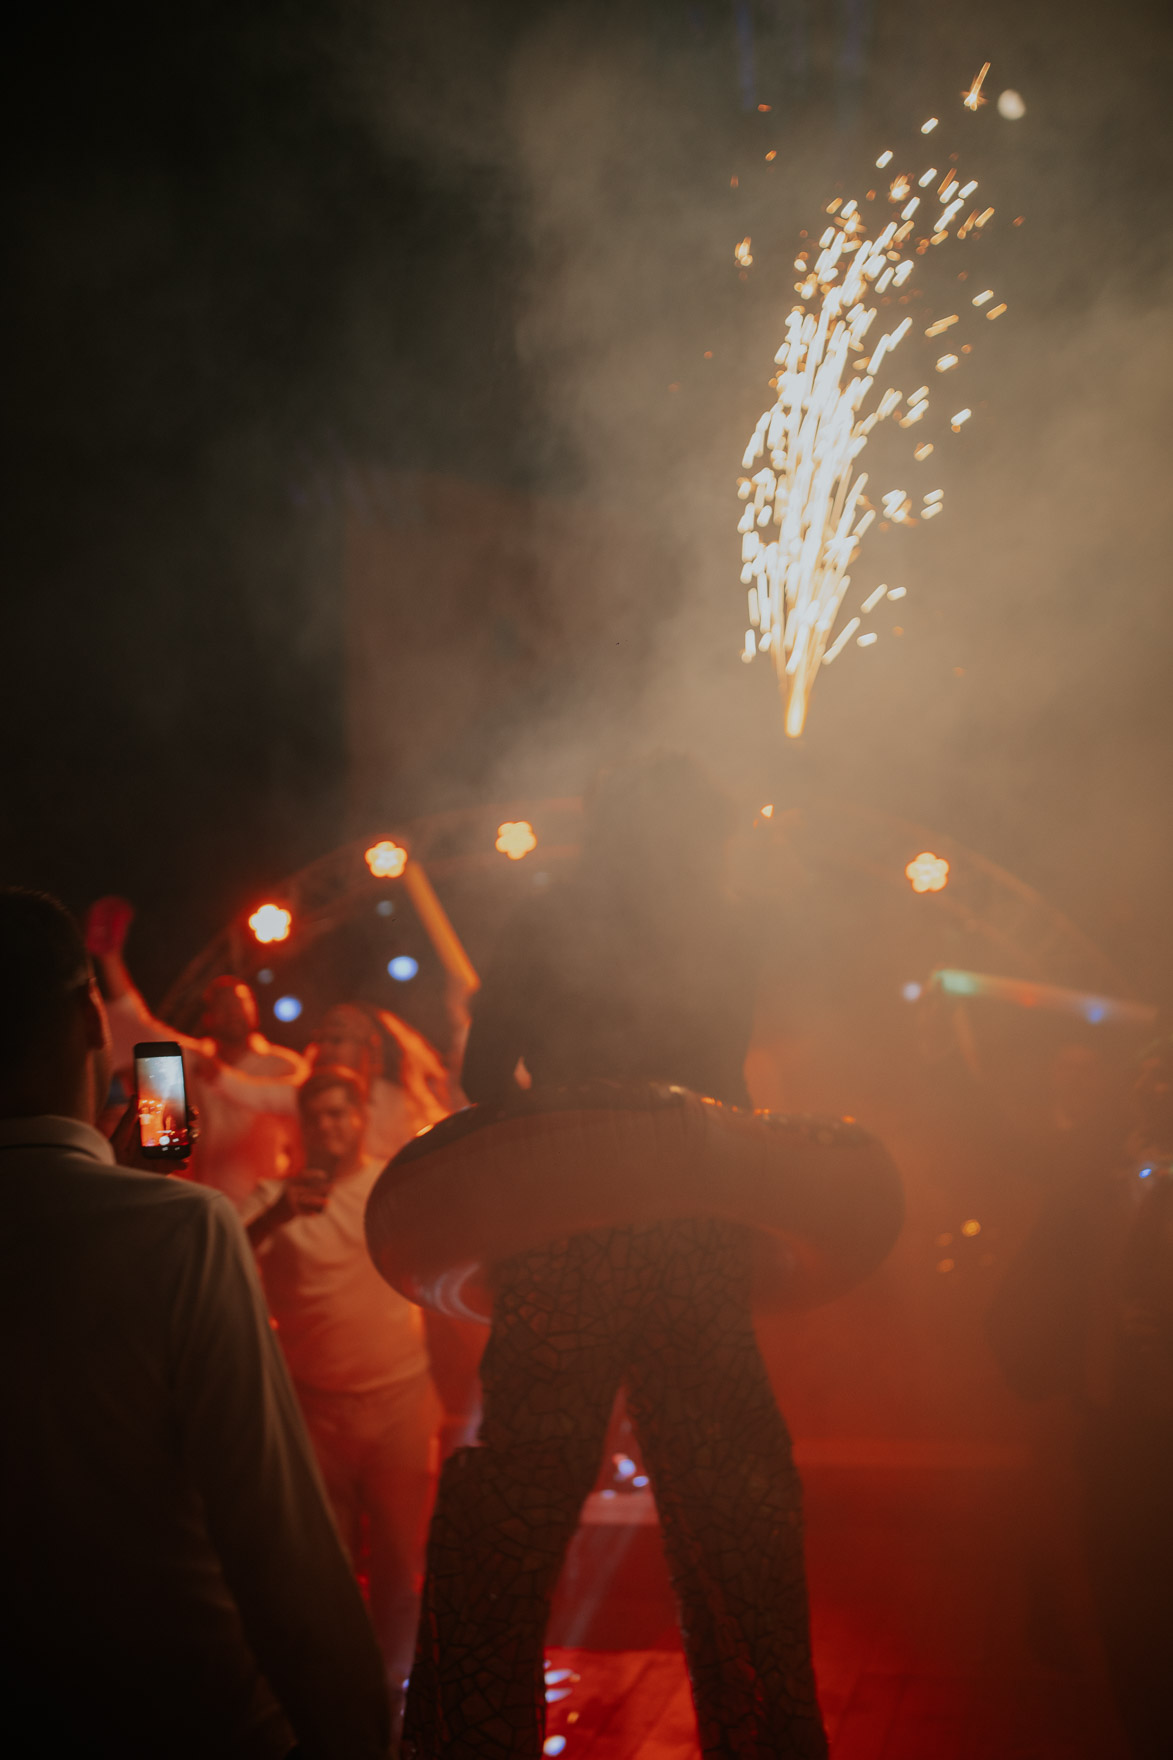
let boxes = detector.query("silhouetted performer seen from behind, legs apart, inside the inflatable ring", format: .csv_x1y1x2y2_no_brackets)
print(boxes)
375,755,900,1760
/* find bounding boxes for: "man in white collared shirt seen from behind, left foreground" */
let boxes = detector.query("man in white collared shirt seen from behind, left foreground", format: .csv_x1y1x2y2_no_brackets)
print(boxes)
0,889,391,1760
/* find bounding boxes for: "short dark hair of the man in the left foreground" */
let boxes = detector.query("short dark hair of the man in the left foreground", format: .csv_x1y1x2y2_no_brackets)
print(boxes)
0,887,90,1075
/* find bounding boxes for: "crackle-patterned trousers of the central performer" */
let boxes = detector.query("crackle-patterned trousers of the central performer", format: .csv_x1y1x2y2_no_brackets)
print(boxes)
403,1218,826,1760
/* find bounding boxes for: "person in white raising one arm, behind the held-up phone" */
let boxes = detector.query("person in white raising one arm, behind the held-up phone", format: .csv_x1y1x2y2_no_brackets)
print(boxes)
86,898,310,1209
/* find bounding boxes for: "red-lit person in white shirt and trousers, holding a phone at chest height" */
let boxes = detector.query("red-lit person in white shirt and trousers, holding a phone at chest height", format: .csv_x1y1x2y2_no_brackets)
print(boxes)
248,1067,442,1698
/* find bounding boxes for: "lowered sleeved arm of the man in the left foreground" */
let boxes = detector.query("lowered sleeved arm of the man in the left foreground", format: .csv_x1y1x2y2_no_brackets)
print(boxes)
171,1197,389,1760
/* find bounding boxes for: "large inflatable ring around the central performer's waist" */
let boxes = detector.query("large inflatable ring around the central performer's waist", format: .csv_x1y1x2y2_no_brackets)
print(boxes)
366,1082,904,1320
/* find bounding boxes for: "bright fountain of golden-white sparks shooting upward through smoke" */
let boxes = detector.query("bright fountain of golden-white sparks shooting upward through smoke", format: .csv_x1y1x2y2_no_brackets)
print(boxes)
734,63,1006,737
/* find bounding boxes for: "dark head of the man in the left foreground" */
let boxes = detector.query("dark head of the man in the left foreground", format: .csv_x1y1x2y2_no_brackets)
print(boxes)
0,887,109,1123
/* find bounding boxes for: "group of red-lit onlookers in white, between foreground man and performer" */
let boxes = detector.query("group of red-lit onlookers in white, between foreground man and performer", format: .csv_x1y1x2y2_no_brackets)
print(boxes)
85,898,481,1702
